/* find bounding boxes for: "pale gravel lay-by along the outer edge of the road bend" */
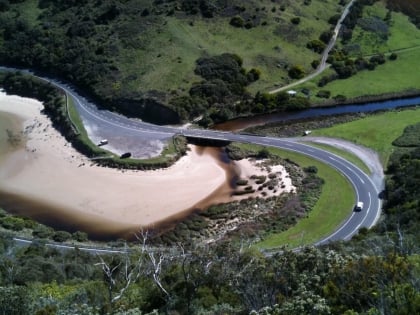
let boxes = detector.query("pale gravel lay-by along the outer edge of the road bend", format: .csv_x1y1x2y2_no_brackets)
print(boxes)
298,137,384,191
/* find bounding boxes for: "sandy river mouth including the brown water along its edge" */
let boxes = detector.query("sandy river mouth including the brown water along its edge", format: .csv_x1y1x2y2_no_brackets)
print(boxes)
0,102,243,241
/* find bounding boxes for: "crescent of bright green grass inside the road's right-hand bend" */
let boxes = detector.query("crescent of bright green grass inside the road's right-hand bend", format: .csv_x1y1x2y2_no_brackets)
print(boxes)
256,149,355,249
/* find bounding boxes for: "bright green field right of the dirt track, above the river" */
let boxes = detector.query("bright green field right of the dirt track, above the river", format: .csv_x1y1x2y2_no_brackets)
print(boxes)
298,2,420,103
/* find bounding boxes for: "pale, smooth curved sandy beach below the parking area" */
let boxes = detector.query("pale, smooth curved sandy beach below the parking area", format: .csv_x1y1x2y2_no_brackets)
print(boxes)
0,92,291,238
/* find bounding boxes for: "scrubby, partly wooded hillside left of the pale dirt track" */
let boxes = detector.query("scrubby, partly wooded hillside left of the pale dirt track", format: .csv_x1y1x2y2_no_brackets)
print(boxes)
0,0,344,120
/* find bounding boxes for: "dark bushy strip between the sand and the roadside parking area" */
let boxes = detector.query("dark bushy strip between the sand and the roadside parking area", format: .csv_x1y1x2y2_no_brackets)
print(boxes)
0,72,187,169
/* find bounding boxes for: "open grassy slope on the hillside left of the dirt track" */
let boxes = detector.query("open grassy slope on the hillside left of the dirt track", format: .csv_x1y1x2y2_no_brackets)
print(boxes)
119,0,341,92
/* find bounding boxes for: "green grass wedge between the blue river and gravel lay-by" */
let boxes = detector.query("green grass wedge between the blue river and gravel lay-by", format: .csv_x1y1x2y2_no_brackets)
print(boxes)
312,108,420,165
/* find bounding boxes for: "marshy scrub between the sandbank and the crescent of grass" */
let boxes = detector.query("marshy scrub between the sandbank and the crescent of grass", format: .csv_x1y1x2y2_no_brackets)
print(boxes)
152,143,332,246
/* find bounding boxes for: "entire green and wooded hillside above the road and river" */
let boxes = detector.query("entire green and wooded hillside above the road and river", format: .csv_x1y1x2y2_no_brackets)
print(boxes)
0,0,420,127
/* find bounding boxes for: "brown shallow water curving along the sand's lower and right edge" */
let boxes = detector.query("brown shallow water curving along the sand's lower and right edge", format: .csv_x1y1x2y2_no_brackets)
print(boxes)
0,147,236,241
